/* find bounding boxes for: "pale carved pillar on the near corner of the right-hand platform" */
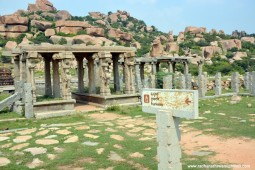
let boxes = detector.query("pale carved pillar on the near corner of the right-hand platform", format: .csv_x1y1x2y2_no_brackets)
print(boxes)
99,52,113,96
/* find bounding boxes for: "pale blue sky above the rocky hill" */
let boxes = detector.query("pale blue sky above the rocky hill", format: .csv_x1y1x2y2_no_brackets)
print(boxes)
0,0,255,35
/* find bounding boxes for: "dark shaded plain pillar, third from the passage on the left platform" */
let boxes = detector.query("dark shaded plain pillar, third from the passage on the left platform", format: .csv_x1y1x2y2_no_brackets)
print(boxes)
44,57,52,97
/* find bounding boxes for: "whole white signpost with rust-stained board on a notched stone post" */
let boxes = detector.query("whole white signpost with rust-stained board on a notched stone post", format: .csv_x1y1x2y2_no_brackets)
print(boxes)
142,89,198,170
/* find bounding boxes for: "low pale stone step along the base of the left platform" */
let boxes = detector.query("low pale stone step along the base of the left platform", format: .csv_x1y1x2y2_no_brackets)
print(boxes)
35,110,76,119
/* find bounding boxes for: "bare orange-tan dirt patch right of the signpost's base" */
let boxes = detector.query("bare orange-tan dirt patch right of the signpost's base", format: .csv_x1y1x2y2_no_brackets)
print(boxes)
181,130,255,169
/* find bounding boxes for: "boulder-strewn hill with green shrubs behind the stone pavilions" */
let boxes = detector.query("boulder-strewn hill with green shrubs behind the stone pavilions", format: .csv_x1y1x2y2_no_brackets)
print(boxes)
0,0,255,74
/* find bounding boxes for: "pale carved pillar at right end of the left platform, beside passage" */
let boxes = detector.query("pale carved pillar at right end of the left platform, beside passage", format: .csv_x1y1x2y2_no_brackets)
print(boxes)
61,52,74,100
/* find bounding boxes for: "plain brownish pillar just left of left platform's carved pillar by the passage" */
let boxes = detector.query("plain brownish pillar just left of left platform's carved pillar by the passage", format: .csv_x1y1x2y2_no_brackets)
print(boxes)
52,53,62,98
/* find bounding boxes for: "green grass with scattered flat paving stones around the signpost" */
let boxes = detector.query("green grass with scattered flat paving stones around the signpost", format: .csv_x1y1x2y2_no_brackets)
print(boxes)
0,97,255,170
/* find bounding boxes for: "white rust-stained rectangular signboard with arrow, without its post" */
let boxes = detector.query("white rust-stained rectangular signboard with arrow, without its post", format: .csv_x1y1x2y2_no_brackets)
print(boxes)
142,89,198,119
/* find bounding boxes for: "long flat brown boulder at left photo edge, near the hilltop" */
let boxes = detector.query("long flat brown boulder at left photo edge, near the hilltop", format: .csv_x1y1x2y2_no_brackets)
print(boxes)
0,15,28,25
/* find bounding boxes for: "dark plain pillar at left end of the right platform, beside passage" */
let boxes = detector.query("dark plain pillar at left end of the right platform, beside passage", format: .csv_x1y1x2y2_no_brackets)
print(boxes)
76,56,85,93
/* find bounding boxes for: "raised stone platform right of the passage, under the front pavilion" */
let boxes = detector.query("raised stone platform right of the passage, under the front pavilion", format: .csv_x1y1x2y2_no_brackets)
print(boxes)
72,92,141,108
